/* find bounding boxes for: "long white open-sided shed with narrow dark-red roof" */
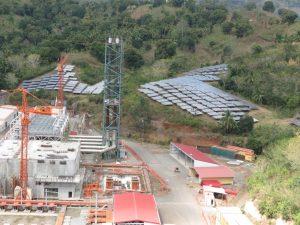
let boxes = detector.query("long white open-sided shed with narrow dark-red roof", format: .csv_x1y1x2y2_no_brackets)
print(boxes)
170,143,218,167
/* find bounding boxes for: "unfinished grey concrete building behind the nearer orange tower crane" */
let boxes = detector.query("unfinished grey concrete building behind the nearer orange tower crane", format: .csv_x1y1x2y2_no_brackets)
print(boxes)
0,140,83,199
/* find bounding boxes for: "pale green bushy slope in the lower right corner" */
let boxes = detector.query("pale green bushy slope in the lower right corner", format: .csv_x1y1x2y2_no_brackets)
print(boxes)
248,136,300,221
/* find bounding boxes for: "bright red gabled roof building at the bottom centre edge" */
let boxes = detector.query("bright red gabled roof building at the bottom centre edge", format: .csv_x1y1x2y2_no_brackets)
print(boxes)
113,192,161,224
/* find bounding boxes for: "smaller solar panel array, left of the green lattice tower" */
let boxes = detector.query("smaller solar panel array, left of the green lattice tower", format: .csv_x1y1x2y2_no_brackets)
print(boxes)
21,65,104,94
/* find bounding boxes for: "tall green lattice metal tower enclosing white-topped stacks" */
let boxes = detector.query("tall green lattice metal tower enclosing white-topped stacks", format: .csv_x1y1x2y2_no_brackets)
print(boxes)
102,38,123,158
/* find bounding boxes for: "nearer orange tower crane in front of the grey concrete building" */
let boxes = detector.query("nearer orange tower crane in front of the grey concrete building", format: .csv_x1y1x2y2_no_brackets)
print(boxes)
0,88,55,199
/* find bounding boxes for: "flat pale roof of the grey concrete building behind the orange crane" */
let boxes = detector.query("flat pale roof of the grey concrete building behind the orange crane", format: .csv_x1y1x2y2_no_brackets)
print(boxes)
0,140,80,161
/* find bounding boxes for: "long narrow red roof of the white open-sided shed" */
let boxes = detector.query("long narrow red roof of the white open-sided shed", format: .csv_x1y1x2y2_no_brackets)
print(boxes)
171,142,217,164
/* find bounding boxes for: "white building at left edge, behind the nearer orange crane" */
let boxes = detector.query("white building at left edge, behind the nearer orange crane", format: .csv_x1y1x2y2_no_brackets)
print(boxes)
0,105,18,133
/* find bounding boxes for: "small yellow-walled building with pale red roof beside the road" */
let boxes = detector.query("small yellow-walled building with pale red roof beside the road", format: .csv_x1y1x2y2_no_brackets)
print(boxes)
194,166,234,184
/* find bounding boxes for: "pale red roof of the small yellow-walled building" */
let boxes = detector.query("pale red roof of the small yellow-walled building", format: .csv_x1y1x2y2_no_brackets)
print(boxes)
194,166,234,178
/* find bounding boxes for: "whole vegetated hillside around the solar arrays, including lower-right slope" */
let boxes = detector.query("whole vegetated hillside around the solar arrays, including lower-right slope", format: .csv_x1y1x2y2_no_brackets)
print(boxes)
0,0,300,221
